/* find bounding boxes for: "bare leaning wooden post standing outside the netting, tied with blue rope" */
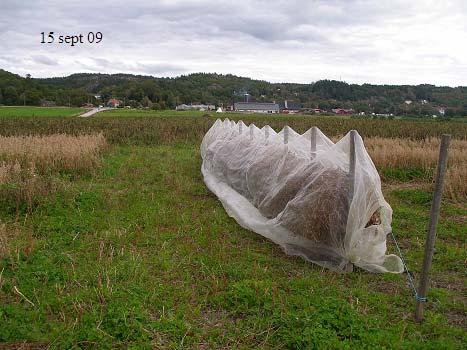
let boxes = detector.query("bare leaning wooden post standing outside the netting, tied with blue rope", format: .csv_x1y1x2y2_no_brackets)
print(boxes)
415,134,451,322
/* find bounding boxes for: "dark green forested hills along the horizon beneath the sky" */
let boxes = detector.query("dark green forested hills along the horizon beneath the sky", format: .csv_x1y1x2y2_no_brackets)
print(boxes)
0,69,467,115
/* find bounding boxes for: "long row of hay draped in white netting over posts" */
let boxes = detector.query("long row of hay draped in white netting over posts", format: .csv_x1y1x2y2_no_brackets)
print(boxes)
201,119,403,273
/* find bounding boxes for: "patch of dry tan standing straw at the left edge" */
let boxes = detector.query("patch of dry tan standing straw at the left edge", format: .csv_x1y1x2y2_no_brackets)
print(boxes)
0,133,107,207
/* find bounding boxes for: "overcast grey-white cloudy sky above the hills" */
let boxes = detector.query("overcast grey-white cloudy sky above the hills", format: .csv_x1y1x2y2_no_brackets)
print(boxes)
0,0,467,86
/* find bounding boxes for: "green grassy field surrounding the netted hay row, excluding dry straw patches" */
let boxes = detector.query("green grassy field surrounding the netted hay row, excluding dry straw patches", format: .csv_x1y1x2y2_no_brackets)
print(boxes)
0,111,467,349
